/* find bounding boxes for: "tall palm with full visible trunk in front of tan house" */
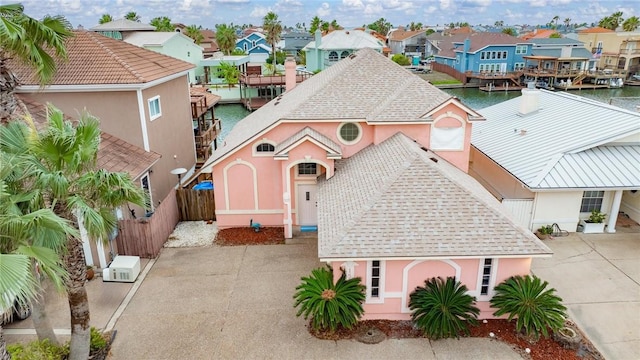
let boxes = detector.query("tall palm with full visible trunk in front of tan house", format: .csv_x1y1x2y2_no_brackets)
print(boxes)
4,106,144,360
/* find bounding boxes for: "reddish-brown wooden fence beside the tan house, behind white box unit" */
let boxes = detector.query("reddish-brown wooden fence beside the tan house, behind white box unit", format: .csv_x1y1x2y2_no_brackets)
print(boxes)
116,190,180,258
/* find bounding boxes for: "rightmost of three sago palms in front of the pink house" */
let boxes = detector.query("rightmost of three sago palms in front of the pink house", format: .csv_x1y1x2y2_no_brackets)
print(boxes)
491,275,567,338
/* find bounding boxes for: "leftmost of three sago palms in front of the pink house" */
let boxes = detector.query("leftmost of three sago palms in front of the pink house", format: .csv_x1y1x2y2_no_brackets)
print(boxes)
293,268,365,331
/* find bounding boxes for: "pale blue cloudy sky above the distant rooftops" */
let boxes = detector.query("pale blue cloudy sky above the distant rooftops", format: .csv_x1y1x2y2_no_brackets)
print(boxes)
16,0,640,29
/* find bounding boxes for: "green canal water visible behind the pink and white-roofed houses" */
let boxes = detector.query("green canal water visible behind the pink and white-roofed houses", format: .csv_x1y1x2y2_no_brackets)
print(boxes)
215,86,640,138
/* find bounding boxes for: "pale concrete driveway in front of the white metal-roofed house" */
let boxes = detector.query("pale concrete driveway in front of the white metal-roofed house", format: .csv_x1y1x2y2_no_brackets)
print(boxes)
532,229,640,360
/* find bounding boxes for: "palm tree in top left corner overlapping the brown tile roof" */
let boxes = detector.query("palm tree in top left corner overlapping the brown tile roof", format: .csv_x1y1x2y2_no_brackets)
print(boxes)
0,4,72,123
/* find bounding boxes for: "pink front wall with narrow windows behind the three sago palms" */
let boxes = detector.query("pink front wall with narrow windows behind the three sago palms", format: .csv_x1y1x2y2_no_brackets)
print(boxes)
331,258,531,320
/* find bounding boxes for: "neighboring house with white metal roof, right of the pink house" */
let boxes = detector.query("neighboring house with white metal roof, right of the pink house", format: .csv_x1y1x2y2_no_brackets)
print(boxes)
470,89,640,232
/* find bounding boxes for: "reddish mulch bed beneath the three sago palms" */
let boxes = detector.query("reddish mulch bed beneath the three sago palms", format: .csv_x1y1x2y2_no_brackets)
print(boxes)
309,320,604,360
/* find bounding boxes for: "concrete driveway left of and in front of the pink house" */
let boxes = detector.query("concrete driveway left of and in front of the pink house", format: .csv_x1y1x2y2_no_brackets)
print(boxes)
110,239,521,360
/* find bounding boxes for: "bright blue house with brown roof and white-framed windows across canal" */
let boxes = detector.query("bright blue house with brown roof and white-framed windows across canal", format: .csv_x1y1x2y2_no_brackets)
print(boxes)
426,32,532,73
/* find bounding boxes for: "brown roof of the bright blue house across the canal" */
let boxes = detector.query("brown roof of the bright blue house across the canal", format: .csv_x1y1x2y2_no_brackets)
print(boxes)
427,32,529,58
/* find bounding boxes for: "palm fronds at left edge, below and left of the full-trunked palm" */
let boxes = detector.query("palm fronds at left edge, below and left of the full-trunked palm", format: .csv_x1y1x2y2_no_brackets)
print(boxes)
0,147,75,359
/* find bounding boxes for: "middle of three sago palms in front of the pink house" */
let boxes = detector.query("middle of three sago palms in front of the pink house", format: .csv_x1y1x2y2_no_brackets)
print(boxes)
409,277,480,339
